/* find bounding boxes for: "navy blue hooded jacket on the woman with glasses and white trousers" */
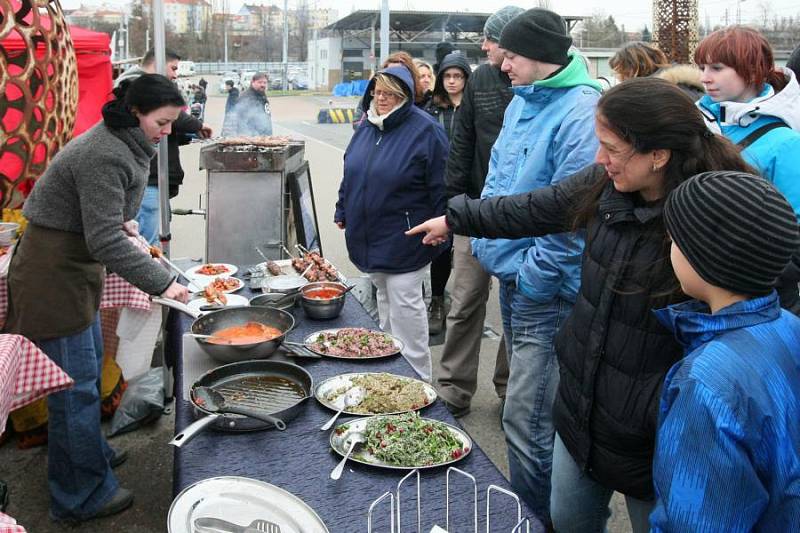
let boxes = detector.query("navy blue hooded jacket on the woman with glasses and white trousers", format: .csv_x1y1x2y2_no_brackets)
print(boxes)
334,67,449,273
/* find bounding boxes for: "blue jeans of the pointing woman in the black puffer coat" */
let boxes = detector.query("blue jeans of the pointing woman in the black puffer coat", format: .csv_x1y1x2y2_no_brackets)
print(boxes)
550,434,655,533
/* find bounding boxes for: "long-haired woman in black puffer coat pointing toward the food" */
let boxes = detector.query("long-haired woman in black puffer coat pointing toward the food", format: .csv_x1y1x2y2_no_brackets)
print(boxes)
408,78,752,532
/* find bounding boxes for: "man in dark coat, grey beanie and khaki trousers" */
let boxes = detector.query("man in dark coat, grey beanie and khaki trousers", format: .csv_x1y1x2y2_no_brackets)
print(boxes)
437,6,524,416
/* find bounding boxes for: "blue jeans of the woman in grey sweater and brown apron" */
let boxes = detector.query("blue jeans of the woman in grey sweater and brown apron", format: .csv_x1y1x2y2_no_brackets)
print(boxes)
39,316,119,520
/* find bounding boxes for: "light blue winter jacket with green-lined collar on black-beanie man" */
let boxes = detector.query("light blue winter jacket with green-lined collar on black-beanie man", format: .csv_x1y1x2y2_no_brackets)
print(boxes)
472,55,600,302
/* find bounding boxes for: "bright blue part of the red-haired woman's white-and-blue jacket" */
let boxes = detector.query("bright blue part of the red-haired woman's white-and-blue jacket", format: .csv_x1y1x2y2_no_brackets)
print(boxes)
697,89,800,220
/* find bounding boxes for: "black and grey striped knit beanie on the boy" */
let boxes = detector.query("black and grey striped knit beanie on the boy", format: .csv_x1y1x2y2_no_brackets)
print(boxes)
664,171,800,296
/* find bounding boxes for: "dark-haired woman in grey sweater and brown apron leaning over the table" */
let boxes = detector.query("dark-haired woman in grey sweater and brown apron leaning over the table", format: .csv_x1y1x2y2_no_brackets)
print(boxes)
5,74,188,522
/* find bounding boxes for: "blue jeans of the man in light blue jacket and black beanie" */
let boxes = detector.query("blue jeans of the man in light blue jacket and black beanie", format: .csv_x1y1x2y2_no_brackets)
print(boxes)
500,283,572,524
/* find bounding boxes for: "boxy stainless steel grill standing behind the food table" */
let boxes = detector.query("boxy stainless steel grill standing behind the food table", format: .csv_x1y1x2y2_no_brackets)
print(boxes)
200,137,316,265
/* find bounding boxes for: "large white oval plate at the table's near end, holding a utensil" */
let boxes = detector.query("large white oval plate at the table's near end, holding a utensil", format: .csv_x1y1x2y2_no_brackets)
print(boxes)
167,476,328,533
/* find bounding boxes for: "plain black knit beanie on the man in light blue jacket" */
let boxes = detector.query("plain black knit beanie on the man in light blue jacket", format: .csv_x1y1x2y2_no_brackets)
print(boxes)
500,7,572,65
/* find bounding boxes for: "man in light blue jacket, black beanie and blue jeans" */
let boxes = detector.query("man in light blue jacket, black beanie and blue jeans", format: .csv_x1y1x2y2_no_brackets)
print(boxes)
472,8,600,524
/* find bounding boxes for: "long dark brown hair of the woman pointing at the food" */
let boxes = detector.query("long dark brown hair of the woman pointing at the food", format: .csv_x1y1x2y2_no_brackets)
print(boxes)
575,78,758,295
